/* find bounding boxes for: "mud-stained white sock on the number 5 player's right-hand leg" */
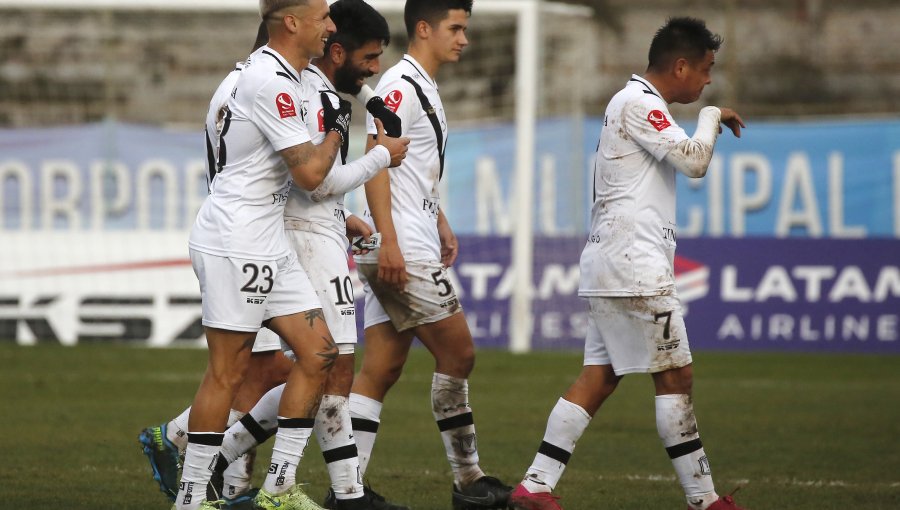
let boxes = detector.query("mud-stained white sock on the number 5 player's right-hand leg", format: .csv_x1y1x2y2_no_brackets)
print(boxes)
431,373,484,487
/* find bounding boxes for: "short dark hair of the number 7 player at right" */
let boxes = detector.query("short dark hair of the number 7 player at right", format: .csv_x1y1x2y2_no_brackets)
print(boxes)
647,18,722,70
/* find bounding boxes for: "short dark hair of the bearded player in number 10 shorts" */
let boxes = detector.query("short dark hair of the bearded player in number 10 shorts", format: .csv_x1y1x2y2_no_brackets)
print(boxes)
325,0,391,53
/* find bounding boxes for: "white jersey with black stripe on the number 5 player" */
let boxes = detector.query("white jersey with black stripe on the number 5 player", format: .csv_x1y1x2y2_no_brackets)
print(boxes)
358,55,447,260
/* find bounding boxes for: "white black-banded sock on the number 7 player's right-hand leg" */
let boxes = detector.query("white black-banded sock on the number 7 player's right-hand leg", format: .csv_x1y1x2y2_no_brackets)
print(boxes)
656,395,719,510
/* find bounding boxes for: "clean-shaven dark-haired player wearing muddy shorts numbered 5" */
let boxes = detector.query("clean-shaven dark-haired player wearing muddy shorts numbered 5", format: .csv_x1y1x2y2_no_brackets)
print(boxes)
350,0,512,509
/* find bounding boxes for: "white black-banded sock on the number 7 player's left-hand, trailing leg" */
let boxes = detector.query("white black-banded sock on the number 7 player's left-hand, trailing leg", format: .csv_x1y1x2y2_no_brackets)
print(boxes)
522,398,591,494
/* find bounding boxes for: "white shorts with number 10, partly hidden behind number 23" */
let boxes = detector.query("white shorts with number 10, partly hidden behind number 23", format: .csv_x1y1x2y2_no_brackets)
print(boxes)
253,229,357,356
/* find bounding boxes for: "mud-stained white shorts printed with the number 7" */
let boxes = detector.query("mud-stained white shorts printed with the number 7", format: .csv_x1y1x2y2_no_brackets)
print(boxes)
584,295,692,375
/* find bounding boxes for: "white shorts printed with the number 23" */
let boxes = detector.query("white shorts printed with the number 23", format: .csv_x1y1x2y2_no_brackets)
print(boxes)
190,250,321,332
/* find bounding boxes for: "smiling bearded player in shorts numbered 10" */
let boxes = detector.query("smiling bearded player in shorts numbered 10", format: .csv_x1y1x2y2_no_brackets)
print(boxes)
207,0,409,510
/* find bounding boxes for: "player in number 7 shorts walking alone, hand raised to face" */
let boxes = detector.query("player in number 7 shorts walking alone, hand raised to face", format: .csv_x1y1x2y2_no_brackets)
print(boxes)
510,18,745,510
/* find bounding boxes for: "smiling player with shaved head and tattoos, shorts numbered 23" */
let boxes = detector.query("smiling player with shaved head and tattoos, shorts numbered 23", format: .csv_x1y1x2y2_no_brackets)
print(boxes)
175,0,350,510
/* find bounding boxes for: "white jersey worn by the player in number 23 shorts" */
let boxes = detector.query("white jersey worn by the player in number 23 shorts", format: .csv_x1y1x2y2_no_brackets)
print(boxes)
189,46,310,260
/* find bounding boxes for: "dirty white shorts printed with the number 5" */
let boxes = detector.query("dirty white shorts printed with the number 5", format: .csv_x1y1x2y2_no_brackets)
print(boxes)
356,261,462,331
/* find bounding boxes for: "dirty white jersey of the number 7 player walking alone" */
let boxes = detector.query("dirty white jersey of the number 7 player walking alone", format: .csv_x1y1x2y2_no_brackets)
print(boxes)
578,76,689,296
